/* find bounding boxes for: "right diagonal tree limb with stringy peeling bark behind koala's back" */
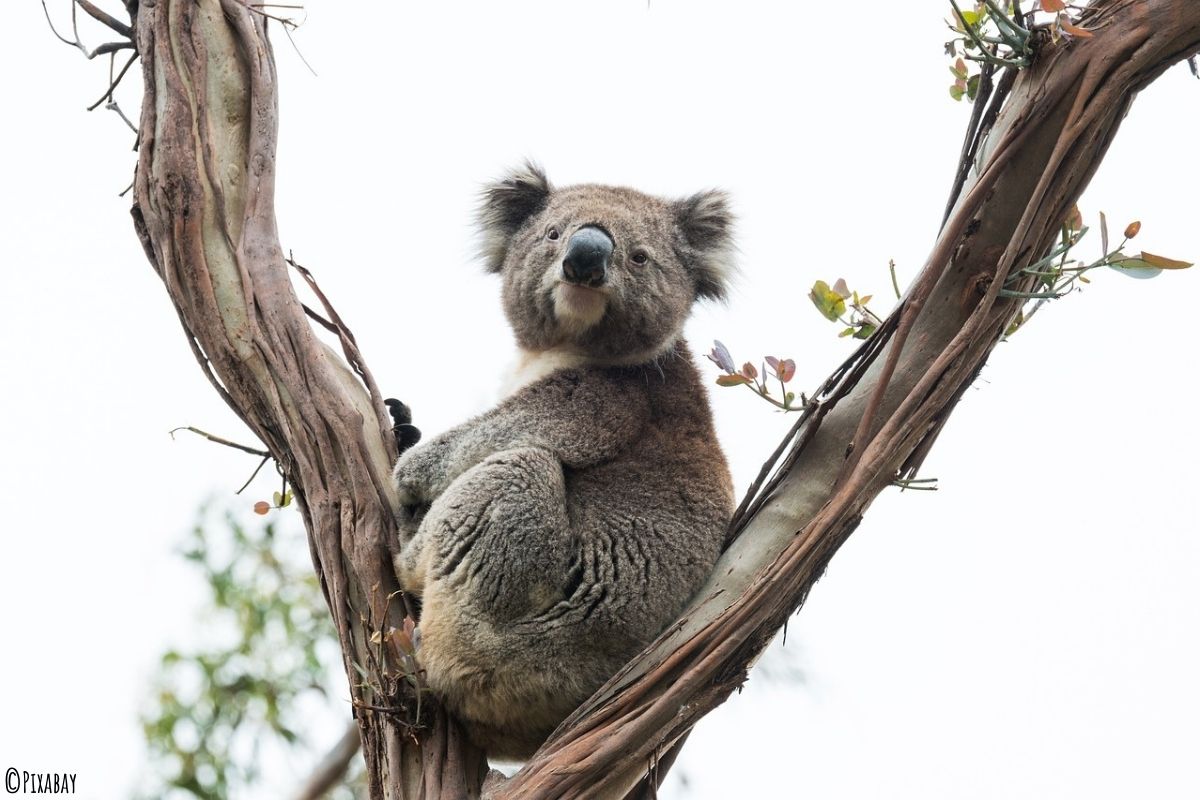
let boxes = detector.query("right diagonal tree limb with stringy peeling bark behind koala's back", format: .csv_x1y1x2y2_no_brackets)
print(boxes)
493,0,1200,799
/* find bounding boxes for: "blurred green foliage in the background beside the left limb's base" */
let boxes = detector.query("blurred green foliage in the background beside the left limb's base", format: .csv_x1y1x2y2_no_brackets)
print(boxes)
139,512,361,800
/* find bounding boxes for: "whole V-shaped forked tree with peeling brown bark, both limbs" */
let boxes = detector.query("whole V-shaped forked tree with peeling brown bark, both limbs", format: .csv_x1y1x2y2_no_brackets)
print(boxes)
124,0,1200,800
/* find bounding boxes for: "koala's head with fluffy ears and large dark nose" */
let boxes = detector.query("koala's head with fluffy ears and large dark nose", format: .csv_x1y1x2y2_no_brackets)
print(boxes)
480,164,733,363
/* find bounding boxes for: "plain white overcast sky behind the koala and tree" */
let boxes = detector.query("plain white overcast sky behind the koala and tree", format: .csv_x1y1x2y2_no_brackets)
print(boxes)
0,0,1200,800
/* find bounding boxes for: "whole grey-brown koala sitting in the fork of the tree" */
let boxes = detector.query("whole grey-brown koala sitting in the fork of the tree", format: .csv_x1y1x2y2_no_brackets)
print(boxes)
394,164,733,759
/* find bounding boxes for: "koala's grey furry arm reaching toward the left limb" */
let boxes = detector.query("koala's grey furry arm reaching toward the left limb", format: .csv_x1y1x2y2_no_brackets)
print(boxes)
394,369,650,505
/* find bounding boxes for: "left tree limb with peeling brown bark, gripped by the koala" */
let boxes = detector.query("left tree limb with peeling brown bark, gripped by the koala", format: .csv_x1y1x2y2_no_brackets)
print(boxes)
133,0,485,799
